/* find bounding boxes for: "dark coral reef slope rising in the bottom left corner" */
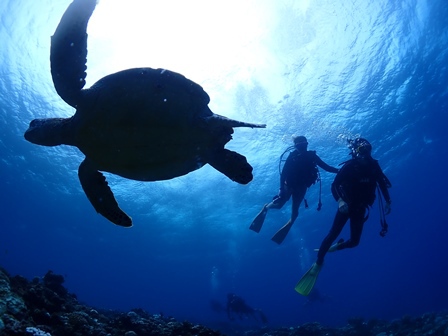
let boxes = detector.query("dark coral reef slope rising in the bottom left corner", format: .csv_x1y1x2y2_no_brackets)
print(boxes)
0,268,222,336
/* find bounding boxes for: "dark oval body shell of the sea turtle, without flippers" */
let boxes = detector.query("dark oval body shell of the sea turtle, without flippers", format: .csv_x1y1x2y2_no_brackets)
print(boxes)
72,68,233,181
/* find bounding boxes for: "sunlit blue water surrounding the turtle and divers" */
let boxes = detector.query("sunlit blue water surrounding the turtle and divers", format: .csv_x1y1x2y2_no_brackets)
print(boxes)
0,0,448,326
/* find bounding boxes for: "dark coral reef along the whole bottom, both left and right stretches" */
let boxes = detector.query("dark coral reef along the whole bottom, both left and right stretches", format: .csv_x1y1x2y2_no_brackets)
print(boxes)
0,268,448,336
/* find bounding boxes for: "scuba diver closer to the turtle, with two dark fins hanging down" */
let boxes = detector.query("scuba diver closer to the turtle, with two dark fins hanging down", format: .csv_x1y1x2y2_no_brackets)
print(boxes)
249,136,338,244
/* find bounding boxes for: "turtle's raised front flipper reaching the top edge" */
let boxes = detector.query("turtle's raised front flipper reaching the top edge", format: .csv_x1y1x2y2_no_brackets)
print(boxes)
50,0,96,108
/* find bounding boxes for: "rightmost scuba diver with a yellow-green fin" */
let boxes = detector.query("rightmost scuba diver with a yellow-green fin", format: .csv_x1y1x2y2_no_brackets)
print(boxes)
295,138,392,295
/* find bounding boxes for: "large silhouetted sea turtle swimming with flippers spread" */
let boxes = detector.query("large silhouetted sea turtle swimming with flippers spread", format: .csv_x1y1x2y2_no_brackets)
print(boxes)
25,0,265,227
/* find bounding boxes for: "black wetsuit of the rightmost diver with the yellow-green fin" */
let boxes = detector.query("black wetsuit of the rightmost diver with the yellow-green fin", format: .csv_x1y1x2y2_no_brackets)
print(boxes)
317,157,390,265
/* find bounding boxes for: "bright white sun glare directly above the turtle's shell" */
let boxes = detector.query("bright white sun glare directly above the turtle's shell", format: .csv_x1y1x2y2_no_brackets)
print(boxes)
87,0,269,88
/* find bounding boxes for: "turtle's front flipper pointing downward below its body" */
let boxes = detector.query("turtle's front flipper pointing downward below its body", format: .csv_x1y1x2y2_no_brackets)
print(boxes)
78,159,132,227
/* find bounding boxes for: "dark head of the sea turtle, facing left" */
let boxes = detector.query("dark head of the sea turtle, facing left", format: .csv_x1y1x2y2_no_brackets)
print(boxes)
25,118,70,146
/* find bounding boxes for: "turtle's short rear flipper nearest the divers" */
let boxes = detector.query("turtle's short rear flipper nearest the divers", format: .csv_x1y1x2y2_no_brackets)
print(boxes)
207,148,253,184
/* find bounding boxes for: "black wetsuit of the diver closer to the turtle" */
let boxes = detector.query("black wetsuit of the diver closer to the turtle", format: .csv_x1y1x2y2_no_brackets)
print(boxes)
272,150,338,222
